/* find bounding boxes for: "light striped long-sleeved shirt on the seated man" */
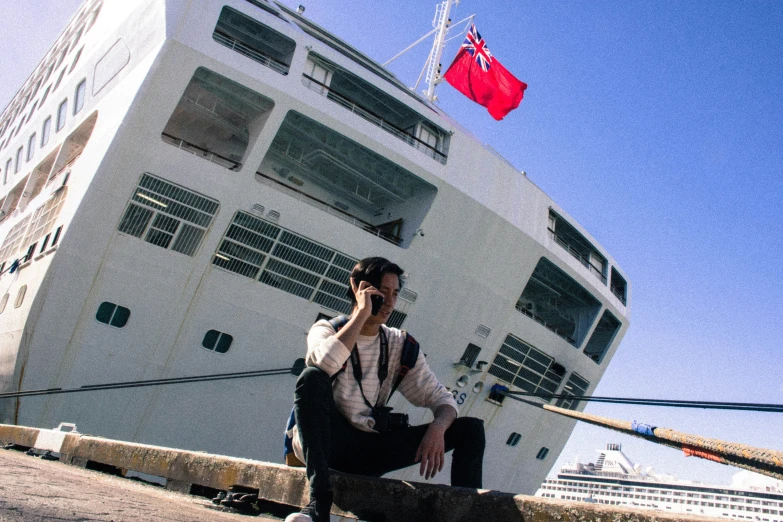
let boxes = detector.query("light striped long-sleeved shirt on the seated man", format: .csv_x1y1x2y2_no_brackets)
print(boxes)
294,320,459,462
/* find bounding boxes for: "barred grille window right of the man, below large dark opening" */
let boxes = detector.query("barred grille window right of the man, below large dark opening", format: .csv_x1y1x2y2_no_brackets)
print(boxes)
489,334,565,394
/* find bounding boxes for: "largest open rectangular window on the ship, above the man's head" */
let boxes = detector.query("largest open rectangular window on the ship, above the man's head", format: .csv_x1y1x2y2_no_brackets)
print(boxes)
256,111,437,248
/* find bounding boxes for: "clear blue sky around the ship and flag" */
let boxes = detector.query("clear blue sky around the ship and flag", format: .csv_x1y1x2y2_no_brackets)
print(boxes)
0,0,783,482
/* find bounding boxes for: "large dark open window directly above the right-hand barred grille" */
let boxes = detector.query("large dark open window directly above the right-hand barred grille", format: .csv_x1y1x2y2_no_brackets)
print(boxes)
516,257,601,347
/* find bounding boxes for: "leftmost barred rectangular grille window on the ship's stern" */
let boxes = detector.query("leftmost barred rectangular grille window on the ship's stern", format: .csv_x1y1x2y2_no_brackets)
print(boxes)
119,174,219,257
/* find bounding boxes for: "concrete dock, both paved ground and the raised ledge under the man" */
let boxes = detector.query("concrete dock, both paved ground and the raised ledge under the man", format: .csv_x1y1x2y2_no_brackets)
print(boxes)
0,424,721,522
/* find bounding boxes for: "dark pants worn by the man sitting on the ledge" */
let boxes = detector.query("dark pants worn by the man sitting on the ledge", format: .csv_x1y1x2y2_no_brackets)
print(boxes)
294,367,484,498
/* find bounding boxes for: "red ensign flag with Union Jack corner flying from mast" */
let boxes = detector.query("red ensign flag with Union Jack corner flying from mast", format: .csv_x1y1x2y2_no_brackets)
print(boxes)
443,25,527,120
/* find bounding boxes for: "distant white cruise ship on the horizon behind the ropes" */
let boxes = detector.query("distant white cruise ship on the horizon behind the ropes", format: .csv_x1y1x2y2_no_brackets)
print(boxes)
536,444,783,522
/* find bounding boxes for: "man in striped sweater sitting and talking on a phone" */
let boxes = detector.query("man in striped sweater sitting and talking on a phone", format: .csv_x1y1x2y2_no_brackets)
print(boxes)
286,257,484,522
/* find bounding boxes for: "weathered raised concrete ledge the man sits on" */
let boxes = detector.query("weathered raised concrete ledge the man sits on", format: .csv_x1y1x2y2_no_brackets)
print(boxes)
0,424,715,522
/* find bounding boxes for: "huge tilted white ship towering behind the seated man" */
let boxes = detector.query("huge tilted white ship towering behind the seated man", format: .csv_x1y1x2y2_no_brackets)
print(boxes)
0,0,630,493
